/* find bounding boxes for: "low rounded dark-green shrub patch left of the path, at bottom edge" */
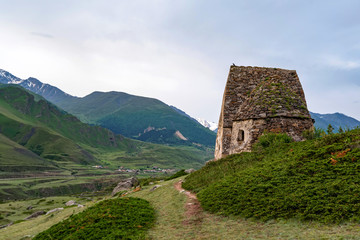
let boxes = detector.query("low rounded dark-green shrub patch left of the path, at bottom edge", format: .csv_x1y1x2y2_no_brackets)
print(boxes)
33,198,155,240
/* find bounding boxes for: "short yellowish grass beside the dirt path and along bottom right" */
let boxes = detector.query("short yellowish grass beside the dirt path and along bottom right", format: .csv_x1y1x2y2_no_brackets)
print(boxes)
130,178,360,240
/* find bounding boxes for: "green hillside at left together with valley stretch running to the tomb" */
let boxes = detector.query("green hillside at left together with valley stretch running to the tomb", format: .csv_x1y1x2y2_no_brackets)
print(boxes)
0,86,212,172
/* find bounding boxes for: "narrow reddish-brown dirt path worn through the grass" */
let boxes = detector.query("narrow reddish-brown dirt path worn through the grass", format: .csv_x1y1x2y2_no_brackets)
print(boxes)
174,181,204,225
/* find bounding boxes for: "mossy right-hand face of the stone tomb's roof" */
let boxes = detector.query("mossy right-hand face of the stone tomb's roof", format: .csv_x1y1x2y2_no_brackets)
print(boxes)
234,71,310,121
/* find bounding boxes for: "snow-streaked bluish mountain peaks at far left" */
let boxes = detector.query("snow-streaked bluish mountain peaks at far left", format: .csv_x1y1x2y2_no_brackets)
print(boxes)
0,69,74,103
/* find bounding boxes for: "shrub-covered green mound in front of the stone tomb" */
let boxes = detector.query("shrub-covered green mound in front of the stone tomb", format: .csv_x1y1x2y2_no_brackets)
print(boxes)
183,128,360,223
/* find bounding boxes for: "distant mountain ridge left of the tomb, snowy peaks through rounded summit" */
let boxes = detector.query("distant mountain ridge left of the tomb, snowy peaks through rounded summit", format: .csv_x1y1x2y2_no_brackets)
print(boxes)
0,70,216,147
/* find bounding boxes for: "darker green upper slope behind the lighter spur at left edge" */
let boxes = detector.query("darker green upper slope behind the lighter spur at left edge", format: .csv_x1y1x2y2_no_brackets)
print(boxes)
0,86,133,149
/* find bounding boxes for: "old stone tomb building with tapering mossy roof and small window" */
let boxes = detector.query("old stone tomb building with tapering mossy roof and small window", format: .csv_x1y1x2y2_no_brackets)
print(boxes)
215,65,313,160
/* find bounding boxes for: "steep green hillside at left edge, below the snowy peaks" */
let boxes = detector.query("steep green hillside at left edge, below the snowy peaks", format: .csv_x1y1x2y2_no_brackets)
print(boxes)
0,86,124,169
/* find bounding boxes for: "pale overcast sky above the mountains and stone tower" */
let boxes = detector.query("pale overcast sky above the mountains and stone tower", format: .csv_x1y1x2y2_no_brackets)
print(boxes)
0,0,360,122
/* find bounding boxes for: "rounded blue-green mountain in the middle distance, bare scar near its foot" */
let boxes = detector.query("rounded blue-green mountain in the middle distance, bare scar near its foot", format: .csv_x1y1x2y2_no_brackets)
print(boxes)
57,92,216,147
